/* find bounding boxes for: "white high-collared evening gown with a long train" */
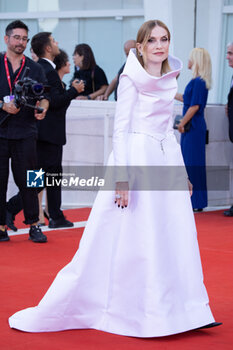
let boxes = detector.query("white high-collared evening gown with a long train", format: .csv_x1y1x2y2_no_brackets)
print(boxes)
9,50,214,337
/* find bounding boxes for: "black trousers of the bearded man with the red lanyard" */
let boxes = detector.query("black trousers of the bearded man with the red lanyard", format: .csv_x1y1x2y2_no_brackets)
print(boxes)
0,136,39,225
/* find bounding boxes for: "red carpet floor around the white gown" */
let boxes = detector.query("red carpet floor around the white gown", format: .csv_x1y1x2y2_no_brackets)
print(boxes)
0,208,233,350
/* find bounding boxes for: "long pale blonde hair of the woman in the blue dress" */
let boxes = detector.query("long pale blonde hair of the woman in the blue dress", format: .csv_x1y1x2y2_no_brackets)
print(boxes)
189,47,212,90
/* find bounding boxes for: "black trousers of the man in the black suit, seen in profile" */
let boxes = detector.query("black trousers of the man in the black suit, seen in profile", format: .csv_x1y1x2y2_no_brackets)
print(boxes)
7,141,64,220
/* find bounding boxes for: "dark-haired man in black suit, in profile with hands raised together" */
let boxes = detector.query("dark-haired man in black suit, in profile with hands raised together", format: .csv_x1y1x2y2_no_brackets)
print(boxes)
31,32,84,228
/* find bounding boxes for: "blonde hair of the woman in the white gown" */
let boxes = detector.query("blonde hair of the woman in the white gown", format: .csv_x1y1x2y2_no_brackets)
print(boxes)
136,19,171,74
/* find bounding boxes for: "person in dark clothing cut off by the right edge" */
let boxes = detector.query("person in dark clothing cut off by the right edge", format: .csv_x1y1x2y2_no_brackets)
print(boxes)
223,43,233,216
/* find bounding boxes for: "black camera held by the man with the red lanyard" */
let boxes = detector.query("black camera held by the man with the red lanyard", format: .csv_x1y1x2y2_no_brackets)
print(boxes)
14,67,49,113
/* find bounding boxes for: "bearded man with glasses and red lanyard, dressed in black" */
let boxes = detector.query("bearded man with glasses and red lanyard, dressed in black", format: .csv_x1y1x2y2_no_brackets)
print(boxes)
0,20,49,243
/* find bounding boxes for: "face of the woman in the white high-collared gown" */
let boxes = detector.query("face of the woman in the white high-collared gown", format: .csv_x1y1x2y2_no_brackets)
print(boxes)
138,26,170,65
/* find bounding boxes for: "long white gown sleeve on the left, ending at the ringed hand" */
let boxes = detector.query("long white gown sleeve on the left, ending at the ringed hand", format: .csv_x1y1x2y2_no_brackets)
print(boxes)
113,75,138,181
